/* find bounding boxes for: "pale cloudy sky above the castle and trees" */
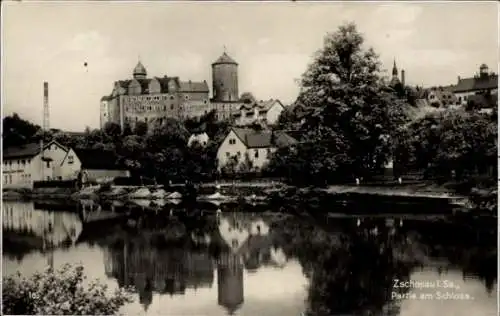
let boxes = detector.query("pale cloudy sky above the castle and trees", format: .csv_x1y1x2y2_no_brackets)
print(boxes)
1,0,499,131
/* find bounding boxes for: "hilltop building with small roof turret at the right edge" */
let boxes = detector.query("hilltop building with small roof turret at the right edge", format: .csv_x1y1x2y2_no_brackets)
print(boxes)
453,64,498,105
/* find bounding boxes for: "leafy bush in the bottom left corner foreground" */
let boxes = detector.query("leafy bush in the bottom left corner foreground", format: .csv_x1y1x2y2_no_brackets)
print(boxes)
2,264,132,315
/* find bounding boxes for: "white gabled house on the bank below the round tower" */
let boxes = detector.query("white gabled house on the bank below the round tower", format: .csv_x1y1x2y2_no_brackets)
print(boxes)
217,127,297,171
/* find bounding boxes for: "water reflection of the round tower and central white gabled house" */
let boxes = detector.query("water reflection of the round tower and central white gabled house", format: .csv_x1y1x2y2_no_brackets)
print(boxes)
217,213,286,315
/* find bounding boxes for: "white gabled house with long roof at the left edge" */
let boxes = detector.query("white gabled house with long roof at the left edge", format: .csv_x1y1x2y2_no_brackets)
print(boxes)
2,141,69,188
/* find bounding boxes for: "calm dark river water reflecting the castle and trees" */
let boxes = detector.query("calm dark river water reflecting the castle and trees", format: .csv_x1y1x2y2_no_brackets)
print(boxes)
3,201,497,316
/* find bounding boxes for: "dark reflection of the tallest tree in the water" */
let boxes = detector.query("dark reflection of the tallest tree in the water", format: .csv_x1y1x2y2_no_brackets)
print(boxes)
277,216,412,315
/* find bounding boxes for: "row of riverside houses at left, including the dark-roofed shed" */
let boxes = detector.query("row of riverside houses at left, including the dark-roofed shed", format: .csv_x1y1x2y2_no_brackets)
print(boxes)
2,141,130,189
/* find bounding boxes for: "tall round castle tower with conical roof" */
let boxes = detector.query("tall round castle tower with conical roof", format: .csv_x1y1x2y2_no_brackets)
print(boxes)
212,52,239,102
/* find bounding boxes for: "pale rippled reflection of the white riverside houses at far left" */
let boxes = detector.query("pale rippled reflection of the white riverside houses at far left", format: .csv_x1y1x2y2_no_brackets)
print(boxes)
2,201,83,248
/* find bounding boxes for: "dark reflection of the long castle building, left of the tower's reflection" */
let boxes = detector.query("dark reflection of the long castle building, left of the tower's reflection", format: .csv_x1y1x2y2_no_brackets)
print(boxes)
104,241,214,309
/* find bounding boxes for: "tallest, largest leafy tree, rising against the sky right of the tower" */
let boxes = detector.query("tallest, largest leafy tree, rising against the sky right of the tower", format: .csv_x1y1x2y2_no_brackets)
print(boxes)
271,24,407,182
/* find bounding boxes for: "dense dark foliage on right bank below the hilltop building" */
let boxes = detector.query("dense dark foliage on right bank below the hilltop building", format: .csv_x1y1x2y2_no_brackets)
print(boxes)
394,110,498,181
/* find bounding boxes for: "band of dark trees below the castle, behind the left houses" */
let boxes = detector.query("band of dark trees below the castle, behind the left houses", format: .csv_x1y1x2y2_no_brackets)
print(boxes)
4,112,229,182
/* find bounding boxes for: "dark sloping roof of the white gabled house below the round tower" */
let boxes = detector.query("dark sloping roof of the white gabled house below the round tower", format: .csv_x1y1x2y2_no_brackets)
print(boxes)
231,127,297,148
